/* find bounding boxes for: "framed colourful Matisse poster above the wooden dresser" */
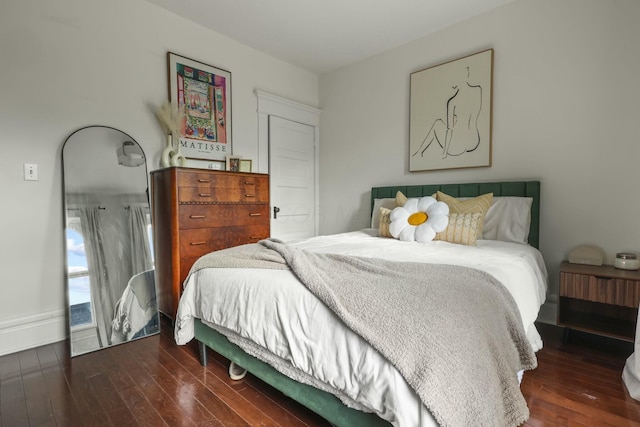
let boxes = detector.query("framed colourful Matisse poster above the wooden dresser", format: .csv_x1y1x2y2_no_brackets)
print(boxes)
167,52,232,162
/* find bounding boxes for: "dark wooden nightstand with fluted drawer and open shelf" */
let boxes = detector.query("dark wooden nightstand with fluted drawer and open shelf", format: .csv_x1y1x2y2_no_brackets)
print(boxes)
557,261,640,341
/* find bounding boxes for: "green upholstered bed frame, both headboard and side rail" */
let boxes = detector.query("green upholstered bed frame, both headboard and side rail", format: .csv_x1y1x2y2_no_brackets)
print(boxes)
195,181,540,427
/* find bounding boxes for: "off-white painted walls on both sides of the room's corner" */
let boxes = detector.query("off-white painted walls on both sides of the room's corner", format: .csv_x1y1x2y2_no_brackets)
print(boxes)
0,0,640,354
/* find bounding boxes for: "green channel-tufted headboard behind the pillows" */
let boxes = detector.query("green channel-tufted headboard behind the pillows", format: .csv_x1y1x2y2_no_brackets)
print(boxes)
371,181,540,248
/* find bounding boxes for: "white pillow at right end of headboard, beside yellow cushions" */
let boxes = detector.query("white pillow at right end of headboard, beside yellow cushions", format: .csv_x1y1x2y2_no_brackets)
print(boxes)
482,197,533,243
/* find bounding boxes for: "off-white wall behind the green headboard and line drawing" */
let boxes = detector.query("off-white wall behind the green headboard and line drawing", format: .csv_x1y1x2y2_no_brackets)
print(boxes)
320,0,640,317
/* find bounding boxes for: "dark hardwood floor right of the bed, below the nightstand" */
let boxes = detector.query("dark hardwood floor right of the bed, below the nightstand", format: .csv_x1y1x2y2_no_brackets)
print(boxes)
521,324,640,427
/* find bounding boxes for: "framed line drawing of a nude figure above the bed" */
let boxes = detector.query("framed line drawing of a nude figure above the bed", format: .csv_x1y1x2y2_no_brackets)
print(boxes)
409,49,493,172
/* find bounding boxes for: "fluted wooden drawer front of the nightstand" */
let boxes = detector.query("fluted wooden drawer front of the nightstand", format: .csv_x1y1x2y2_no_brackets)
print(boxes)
560,272,640,308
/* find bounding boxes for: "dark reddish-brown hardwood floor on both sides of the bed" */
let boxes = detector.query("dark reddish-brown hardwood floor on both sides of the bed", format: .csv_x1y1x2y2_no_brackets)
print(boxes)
0,321,640,427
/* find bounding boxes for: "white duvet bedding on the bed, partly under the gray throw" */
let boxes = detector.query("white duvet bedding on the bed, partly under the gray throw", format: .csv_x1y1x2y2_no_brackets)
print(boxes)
175,229,547,426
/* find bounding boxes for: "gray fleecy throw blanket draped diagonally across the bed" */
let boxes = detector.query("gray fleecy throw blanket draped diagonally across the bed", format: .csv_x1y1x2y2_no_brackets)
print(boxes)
192,239,537,427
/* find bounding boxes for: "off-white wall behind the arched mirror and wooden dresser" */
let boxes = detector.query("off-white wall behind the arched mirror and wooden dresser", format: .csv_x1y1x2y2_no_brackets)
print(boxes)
0,0,318,354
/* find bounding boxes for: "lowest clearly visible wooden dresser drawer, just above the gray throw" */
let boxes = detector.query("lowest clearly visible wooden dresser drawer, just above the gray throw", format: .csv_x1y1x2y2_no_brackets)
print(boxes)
180,224,269,258
